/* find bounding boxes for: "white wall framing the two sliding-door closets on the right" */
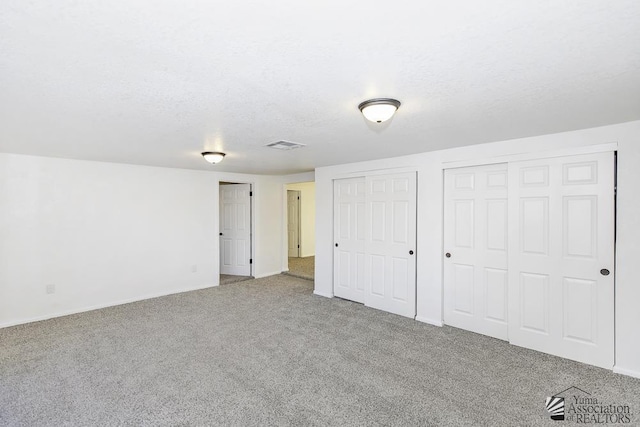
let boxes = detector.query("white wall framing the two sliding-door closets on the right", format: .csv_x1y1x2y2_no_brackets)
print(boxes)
314,121,640,377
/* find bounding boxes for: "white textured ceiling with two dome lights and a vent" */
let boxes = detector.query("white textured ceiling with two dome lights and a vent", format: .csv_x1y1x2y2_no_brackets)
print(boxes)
0,0,640,174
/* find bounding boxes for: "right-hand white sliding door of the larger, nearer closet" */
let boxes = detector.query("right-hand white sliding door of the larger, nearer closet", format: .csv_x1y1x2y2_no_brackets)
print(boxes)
509,153,614,369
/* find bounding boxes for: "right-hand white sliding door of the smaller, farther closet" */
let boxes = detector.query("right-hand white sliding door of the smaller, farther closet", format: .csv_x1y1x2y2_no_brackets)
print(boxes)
364,172,416,317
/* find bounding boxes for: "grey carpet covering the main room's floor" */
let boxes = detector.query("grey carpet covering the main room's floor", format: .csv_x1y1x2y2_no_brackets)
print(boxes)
0,275,640,427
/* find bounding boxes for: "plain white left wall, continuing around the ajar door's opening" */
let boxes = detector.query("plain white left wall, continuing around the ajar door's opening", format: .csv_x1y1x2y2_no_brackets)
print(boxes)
0,154,283,327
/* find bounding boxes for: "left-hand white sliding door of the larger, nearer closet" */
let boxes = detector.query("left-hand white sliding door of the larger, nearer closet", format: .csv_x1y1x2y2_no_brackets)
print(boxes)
444,163,508,340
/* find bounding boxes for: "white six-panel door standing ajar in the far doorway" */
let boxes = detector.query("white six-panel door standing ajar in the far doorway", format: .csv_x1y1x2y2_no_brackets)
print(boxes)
220,184,251,276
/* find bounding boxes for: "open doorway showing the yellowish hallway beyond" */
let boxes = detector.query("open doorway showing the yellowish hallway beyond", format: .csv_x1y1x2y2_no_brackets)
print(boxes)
286,182,316,280
